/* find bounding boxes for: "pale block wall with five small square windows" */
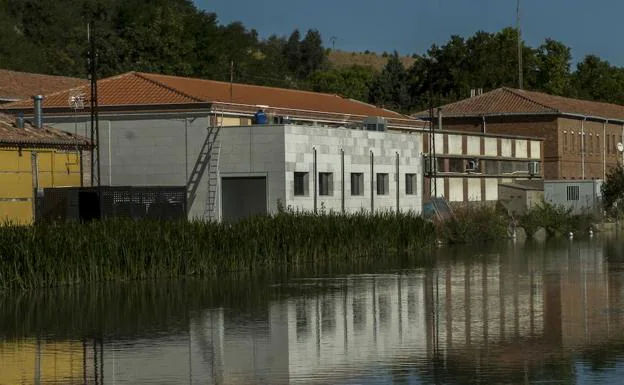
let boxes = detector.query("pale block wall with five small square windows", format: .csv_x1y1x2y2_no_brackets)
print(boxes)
285,126,422,212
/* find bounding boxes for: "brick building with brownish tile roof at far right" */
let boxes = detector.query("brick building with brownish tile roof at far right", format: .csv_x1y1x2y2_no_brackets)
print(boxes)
416,88,624,179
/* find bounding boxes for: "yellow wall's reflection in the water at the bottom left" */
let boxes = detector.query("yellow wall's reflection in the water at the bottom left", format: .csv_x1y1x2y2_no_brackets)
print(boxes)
0,342,84,385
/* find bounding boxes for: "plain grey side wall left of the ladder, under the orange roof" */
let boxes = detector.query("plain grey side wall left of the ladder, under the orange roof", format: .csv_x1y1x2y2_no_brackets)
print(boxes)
50,115,214,218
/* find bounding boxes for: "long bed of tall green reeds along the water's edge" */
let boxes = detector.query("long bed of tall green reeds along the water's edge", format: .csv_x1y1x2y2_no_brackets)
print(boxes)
0,212,435,290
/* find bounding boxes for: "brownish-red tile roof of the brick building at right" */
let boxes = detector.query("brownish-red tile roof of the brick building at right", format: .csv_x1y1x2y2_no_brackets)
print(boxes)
414,88,624,120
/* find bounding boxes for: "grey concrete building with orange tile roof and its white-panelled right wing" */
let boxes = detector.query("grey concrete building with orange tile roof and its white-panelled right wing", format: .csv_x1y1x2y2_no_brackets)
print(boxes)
3,72,544,219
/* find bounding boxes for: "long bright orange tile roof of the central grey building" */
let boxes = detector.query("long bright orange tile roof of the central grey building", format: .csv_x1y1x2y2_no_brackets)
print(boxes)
0,72,422,126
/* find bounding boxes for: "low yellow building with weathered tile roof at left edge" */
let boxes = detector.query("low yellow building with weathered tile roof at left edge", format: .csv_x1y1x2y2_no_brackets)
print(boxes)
0,113,91,224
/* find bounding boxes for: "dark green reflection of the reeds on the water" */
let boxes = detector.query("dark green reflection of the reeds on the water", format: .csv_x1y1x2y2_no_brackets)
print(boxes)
0,255,438,340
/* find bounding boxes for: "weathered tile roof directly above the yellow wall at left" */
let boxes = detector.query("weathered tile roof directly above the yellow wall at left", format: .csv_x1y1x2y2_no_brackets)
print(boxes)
0,113,90,148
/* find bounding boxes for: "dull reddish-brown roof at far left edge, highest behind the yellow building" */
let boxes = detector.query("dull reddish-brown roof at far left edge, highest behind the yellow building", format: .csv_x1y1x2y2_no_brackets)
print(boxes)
0,69,87,101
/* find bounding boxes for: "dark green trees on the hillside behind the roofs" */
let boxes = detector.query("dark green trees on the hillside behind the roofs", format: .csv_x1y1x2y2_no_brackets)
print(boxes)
0,0,624,113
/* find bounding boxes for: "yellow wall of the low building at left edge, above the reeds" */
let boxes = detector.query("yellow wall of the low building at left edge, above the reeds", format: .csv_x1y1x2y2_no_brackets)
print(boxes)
0,149,80,224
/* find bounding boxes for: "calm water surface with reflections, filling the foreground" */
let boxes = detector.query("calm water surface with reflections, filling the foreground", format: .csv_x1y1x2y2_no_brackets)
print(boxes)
0,239,624,385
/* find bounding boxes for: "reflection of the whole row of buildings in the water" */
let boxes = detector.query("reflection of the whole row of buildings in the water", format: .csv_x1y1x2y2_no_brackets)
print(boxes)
0,238,624,384
